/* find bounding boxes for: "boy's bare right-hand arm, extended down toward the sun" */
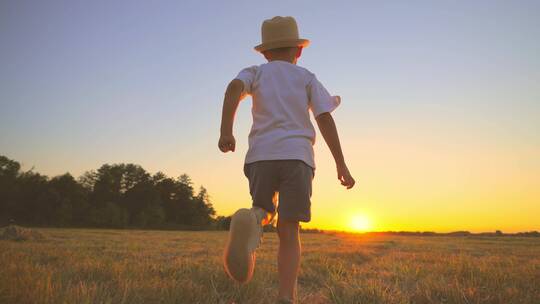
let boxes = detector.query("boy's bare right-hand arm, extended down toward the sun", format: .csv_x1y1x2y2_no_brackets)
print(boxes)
315,112,355,189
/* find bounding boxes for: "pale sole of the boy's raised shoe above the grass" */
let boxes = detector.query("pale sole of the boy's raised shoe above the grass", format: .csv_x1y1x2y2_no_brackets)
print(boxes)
224,209,257,283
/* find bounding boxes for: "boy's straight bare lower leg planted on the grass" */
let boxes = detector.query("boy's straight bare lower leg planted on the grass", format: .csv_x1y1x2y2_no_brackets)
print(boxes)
277,217,301,300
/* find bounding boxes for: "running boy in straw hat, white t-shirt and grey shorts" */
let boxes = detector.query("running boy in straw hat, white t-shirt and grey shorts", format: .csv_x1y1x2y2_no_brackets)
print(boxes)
218,16,355,303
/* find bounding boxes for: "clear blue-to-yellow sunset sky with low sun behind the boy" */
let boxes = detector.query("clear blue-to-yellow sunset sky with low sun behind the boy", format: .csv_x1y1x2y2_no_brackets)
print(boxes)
0,1,540,231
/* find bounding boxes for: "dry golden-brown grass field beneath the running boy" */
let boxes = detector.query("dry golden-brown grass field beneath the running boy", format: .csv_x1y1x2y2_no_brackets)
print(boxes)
0,229,540,304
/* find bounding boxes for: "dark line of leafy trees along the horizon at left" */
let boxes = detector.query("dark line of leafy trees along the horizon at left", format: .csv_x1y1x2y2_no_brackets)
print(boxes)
0,155,230,229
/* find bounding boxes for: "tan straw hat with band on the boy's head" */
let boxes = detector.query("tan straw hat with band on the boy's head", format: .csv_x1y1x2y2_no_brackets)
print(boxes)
255,16,309,52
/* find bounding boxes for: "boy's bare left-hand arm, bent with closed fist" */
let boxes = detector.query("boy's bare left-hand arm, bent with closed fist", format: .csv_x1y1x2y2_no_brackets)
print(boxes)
218,79,244,153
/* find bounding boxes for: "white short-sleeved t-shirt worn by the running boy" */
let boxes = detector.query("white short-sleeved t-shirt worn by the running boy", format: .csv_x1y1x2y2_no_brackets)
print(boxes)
236,60,341,168
